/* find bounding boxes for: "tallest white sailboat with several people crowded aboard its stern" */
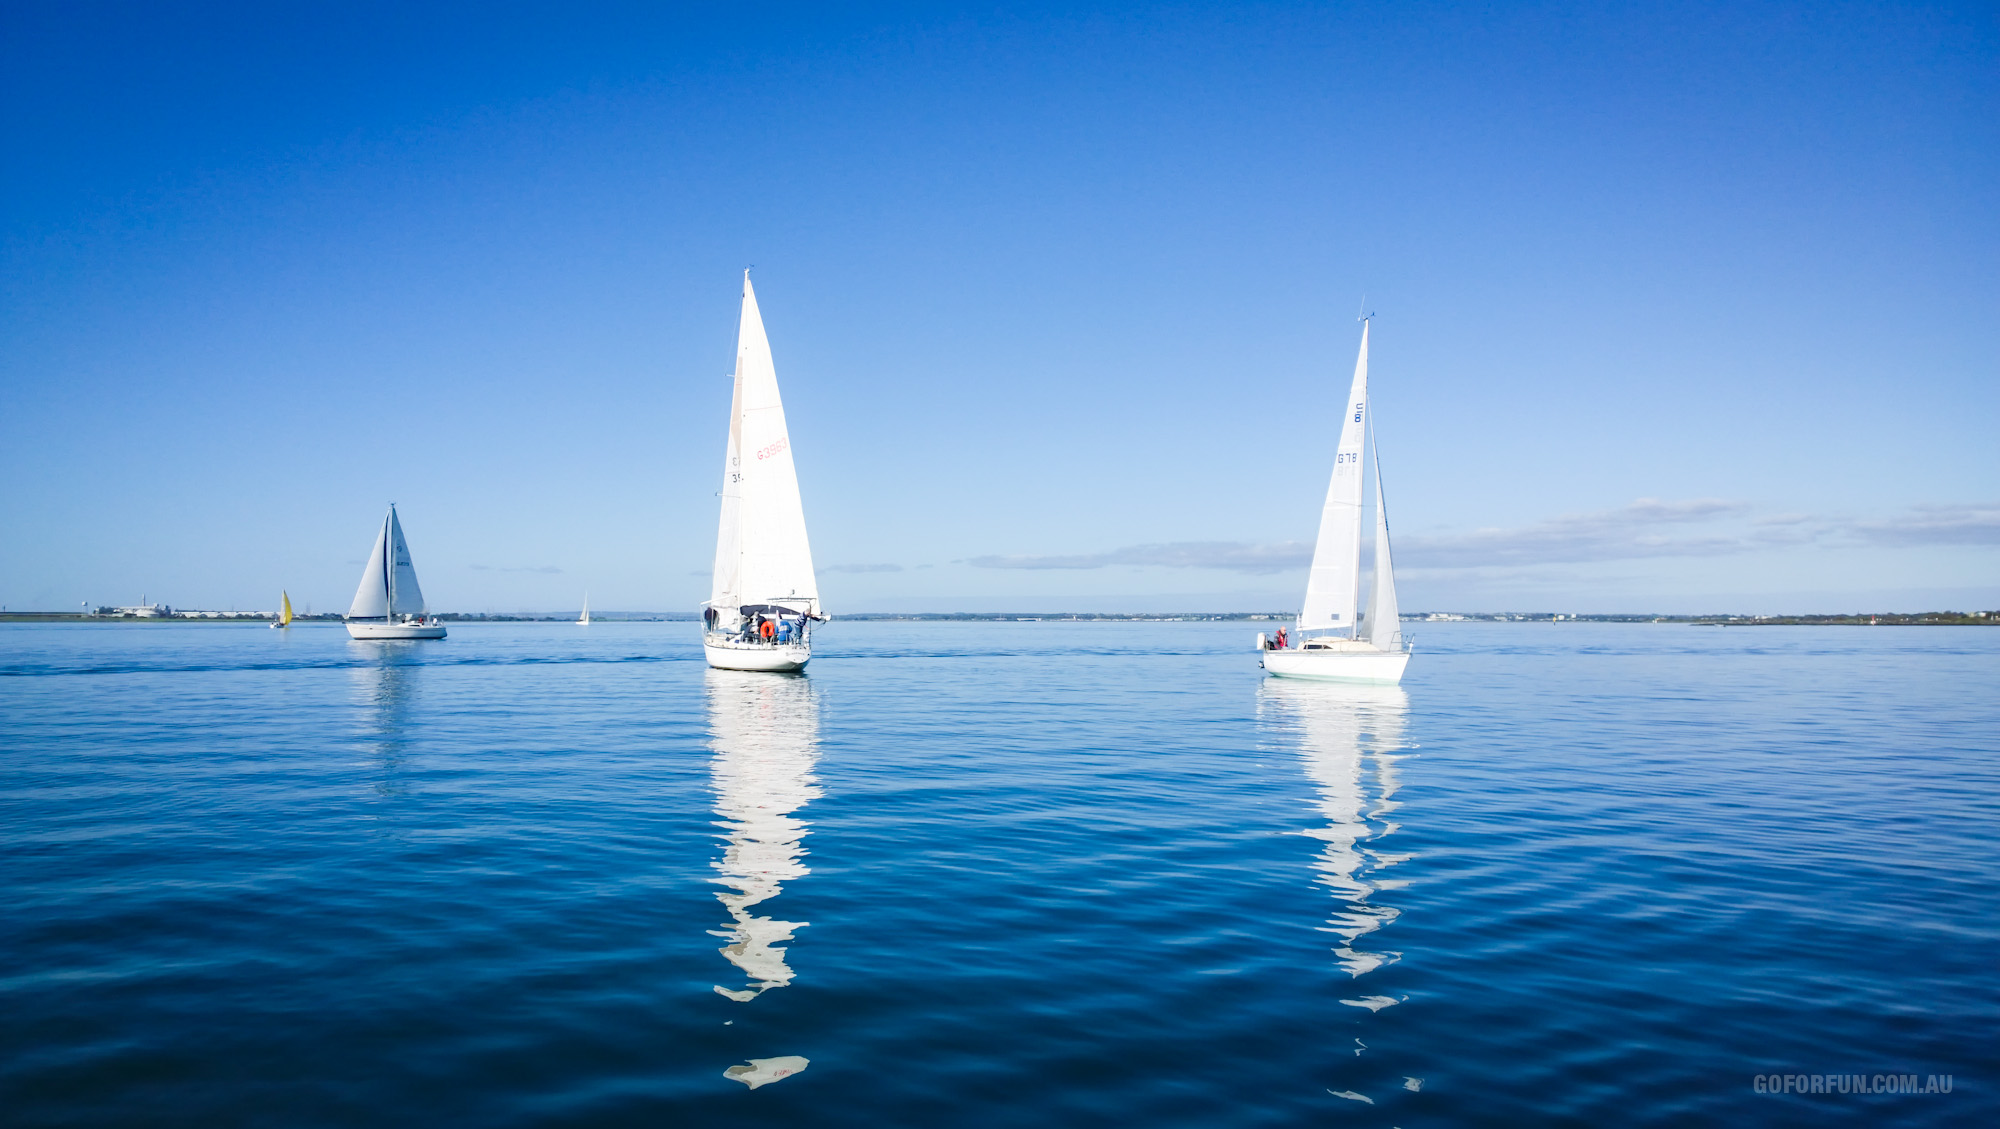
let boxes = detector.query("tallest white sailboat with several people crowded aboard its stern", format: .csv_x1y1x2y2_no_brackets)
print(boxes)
702,270,826,671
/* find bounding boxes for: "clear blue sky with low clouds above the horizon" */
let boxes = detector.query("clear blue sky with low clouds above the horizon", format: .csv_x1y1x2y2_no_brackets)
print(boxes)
0,4,2000,615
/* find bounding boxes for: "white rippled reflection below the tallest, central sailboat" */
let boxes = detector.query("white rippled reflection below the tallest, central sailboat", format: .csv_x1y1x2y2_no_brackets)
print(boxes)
704,669,822,1003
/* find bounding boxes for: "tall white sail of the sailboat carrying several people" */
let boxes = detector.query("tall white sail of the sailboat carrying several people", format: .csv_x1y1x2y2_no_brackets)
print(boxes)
708,272,820,615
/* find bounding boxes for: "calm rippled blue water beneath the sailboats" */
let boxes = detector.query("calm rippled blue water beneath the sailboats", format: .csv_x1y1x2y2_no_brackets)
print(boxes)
0,623,2000,1127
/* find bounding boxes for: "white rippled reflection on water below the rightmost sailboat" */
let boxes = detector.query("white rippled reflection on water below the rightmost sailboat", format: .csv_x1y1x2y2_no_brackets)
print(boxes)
1258,679,1410,980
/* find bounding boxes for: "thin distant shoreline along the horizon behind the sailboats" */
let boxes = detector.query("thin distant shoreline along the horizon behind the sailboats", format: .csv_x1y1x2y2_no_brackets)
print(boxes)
0,611,2000,627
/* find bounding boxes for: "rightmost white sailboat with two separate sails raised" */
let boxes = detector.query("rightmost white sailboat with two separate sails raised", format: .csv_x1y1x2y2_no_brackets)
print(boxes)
1258,318,1410,685
